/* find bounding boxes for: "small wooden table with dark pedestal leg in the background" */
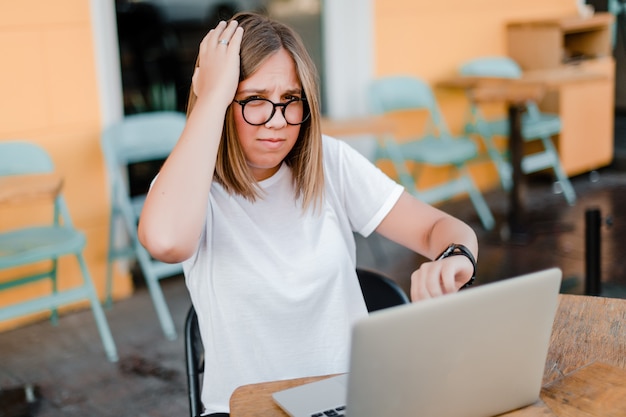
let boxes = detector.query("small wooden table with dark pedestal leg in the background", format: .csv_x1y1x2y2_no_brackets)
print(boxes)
437,66,606,244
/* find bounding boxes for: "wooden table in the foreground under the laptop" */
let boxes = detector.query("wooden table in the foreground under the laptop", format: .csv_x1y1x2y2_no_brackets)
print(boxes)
230,295,626,417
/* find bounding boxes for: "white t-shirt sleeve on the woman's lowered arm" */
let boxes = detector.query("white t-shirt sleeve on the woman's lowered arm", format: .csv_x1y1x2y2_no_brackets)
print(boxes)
324,136,404,237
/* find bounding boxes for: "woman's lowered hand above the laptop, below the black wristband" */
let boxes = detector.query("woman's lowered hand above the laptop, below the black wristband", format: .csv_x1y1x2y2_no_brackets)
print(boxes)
411,256,474,301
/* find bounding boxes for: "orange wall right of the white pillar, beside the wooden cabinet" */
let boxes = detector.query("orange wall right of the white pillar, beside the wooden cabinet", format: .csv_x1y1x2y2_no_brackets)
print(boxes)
373,0,577,189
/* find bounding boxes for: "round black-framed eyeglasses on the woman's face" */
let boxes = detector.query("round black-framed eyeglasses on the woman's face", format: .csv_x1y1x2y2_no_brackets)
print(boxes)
234,97,311,126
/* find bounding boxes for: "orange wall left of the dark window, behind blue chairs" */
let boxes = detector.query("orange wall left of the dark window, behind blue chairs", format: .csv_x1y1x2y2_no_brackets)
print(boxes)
0,0,131,330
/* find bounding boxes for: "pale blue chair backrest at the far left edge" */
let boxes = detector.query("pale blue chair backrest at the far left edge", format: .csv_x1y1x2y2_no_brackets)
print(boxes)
0,141,54,176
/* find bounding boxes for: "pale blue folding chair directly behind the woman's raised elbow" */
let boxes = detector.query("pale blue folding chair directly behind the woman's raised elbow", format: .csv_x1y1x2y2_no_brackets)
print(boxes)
101,111,186,340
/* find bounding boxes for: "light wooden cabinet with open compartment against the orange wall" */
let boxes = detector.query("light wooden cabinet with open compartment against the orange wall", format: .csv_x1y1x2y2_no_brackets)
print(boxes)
506,13,615,176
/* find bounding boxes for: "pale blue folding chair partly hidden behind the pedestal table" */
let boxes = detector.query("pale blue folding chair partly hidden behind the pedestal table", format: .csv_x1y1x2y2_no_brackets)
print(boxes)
459,56,576,205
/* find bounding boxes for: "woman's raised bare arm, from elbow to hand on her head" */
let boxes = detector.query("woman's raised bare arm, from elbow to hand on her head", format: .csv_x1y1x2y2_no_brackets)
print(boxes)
138,20,243,263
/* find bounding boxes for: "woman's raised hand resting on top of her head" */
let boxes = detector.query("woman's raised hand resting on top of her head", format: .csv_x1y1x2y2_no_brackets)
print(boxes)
192,20,243,105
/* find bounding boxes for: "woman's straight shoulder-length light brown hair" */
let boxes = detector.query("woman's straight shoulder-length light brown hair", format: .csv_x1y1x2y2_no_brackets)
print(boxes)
187,12,324,209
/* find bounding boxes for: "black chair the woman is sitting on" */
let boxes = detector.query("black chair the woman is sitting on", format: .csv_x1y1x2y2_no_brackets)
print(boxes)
184,268,410,417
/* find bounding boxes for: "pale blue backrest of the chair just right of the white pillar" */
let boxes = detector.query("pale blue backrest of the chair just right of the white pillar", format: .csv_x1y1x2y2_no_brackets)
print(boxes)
367,75,450,137
